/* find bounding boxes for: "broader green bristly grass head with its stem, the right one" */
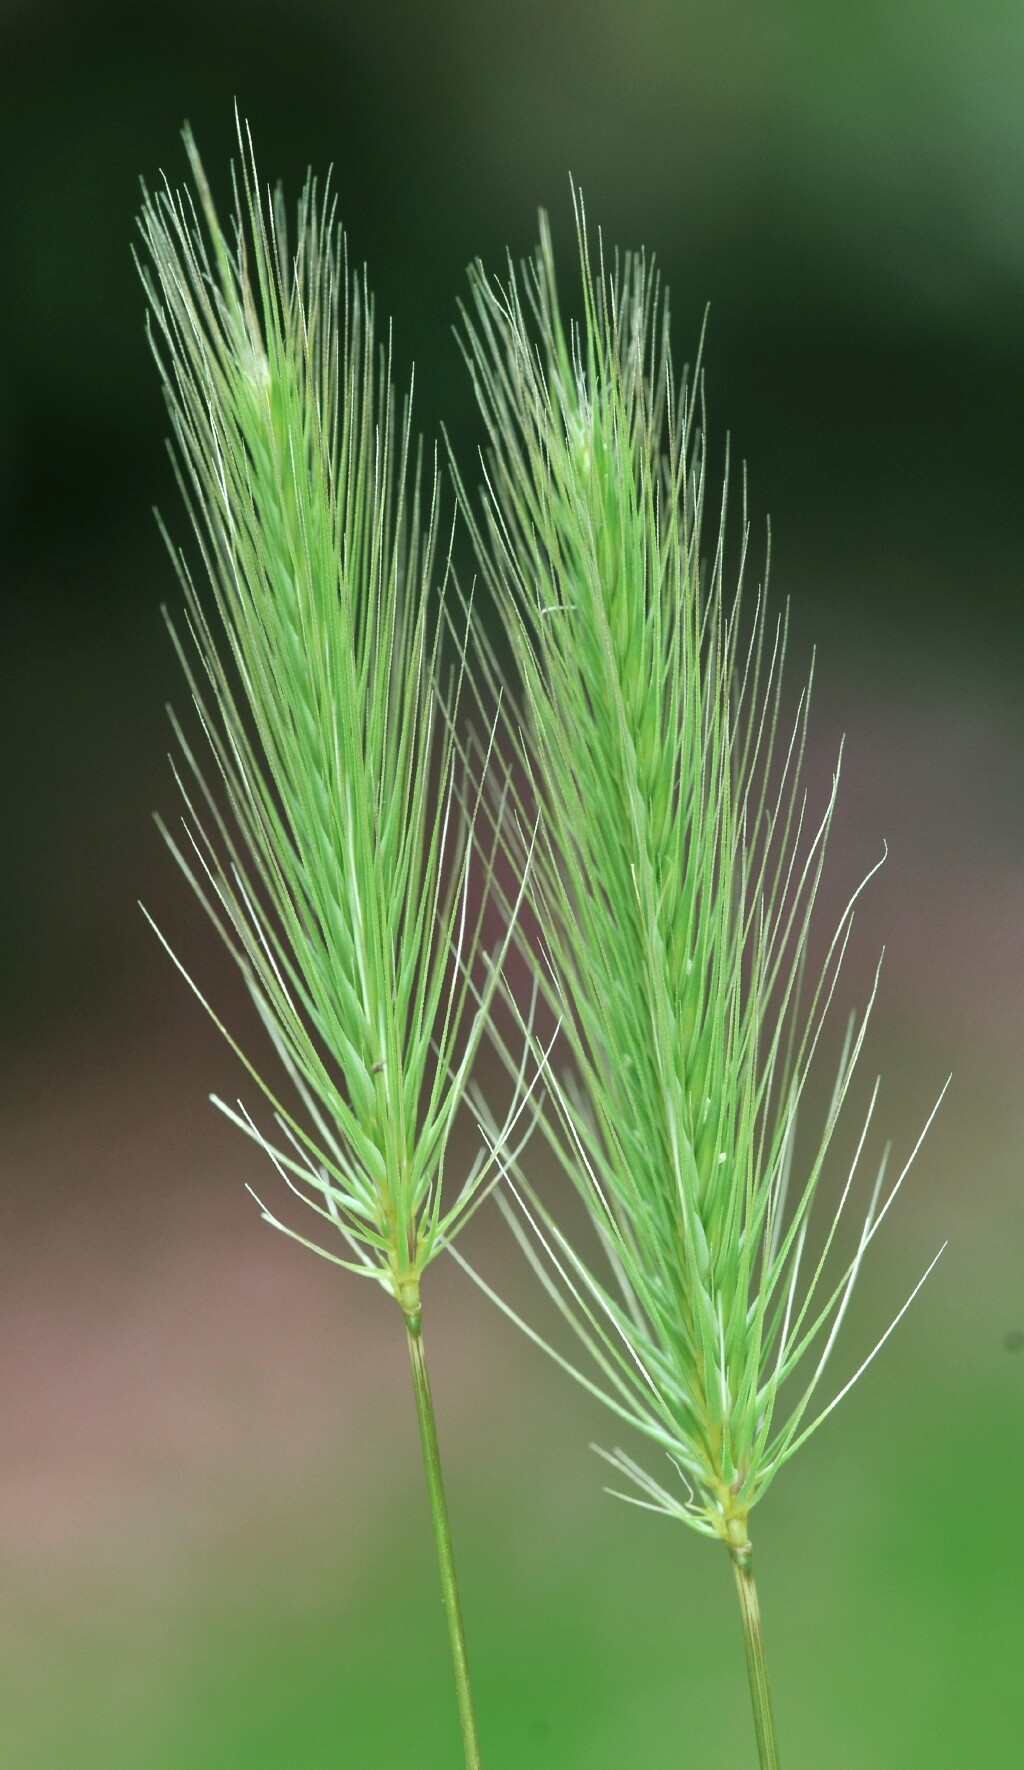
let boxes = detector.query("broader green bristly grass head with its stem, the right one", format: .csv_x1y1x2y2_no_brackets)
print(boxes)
456,209,934,1766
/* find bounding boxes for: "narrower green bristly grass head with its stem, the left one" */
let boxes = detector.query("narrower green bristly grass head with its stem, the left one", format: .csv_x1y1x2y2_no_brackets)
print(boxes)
141,131,537,1766
